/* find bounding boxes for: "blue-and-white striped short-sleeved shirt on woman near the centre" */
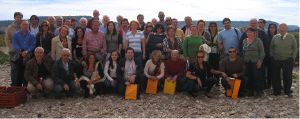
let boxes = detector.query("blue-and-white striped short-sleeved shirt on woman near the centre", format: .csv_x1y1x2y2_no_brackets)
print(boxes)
126,31,144,52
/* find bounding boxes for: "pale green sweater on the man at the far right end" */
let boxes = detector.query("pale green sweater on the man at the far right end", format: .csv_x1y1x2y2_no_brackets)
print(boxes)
270,33,297,60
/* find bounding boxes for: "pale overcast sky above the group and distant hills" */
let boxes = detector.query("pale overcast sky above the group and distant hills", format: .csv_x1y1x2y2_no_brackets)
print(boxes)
0,0,299,26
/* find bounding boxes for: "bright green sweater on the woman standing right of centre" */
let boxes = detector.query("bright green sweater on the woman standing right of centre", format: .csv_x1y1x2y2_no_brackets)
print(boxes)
182,36,204,58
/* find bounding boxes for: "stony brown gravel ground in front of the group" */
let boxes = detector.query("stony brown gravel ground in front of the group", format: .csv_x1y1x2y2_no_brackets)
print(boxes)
0,65,299,118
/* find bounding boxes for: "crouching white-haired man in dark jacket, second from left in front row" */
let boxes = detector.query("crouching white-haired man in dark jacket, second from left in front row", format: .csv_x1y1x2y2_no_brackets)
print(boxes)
52,48,79,98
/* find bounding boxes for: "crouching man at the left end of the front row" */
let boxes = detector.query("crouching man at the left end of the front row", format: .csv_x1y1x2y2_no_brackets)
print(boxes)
24,47,53,98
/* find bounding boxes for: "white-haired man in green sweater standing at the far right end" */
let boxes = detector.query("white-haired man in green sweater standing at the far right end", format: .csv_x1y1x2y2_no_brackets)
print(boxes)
270,23,298,97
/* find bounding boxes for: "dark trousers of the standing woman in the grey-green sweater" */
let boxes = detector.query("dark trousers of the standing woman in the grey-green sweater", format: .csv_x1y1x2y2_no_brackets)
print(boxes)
246,62,264,92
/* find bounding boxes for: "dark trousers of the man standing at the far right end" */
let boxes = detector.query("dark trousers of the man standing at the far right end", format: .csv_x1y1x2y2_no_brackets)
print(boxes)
272,58,293,94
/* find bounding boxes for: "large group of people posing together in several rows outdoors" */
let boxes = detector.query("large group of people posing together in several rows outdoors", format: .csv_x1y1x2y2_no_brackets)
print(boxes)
5,10,297,98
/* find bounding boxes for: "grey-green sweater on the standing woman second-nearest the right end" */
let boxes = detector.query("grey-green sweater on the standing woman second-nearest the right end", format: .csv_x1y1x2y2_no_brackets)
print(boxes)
243,38,265,63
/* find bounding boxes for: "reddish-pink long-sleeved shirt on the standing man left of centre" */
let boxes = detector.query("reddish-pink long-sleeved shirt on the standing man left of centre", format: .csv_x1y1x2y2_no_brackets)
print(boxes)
82,32,106,55
